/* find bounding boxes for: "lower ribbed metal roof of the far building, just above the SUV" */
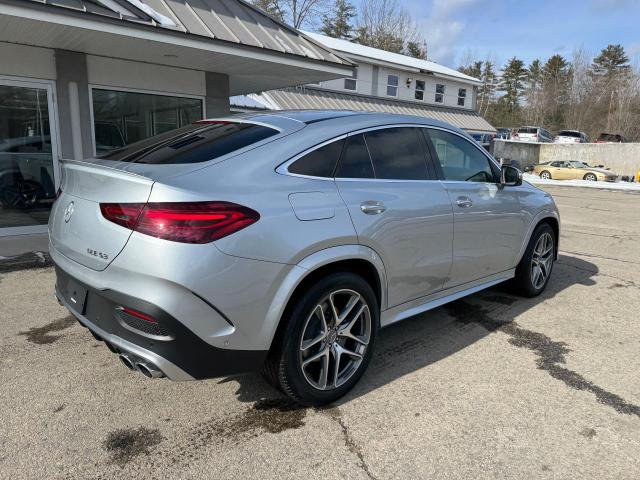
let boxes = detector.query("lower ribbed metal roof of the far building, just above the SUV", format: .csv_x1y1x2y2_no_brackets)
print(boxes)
260,87,496,132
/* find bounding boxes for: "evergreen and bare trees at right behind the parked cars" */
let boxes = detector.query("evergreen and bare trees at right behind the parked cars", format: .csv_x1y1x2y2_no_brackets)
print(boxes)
458,45,640,140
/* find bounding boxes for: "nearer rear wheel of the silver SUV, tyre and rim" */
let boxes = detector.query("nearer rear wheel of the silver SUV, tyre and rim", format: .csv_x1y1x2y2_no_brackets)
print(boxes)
265,272,379,406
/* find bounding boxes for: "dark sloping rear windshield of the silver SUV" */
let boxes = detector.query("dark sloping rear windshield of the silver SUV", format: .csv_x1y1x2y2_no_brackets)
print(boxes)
98,122,278,164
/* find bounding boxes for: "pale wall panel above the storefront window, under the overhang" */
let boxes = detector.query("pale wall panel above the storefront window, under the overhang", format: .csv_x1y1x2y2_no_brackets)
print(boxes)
87,55,206,96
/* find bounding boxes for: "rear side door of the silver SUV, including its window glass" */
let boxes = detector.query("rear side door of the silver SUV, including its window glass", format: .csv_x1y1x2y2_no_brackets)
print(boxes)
335,127,453,308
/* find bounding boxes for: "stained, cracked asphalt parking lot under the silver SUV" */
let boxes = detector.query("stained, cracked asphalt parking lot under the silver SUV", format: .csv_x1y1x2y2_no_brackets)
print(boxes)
0,187,640,479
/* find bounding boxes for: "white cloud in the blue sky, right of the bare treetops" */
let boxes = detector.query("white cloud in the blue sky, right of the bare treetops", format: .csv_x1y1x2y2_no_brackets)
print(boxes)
419,0,482,65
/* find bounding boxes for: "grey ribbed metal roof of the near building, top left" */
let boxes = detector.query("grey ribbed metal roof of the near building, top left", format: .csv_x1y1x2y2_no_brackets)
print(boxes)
23,0,351,66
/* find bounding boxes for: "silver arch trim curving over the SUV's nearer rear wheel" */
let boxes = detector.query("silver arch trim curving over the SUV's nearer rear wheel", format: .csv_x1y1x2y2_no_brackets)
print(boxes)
262,245,387,345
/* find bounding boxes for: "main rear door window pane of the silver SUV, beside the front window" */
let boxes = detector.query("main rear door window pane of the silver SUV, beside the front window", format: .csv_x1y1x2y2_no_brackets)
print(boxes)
365,127,428,180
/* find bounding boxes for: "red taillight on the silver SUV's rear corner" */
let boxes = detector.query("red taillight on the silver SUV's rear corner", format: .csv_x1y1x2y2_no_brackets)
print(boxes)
100,202,260,243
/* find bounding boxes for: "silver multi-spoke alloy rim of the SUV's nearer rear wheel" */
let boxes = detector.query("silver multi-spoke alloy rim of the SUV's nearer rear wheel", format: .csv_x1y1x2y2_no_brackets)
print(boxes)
299,289,371,390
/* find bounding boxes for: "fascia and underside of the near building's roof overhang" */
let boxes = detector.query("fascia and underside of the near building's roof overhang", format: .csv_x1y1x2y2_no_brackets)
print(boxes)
0,0,352,95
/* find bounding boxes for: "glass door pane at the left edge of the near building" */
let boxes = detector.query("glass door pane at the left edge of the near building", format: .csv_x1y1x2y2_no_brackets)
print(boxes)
0,84,55,228
